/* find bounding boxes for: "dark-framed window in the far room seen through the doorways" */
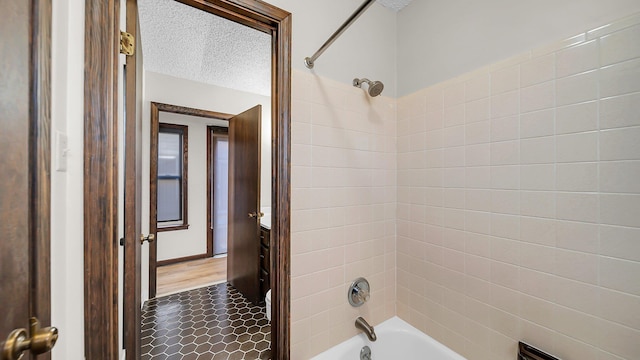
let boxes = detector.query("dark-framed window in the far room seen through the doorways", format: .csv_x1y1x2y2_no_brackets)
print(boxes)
157,124,189,231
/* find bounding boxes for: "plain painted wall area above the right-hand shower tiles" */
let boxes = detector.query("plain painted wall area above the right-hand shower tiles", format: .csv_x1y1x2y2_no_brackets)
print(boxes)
397,0,640,96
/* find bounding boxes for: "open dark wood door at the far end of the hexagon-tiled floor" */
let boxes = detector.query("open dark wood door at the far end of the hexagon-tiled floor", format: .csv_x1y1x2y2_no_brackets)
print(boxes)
227,105,262,304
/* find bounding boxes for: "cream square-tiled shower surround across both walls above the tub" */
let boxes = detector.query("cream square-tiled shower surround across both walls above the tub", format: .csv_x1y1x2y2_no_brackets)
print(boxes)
291,10,640,360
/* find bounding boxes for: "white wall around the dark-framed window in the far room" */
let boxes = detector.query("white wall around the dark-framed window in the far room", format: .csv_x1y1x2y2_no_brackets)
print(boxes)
157,111,228,261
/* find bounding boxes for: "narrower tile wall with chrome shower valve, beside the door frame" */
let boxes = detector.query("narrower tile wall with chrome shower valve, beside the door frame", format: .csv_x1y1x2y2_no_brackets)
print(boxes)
291,71,396,359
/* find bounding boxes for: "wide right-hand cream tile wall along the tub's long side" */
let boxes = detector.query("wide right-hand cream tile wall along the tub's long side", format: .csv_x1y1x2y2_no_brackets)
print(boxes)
397,12,640,360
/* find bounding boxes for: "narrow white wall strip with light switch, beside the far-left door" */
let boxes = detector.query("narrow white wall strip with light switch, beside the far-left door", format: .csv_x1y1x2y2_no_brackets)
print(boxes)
51,0,84,360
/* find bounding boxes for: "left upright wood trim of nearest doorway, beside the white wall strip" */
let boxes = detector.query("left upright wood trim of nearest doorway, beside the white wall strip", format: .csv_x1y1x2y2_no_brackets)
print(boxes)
83,0,120,359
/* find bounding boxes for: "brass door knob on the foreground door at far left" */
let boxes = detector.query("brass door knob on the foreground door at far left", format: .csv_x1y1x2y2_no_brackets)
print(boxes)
0,318,58,360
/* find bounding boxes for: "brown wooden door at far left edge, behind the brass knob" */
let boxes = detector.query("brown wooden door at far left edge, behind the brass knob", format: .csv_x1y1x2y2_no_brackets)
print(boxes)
0,0,51,359
